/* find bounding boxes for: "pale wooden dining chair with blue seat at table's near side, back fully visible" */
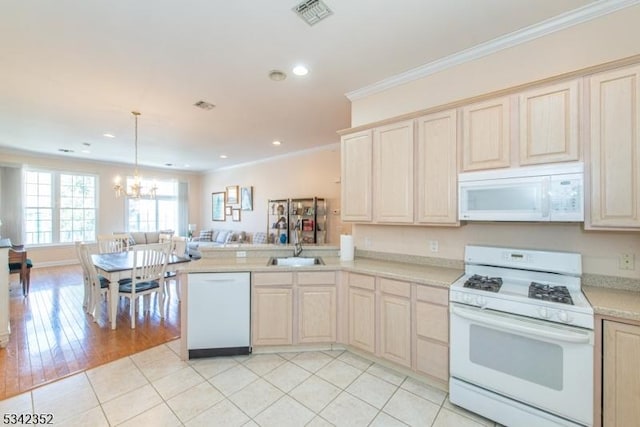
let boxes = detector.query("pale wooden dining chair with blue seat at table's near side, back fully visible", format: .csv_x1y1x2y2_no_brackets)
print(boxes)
119,242,171,329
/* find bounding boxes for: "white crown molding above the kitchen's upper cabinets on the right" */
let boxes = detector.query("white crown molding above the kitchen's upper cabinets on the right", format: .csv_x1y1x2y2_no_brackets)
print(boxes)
345,0,640,101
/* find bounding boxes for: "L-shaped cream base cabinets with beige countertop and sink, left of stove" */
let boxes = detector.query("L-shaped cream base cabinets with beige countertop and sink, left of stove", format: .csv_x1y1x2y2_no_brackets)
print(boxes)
181,246,463,390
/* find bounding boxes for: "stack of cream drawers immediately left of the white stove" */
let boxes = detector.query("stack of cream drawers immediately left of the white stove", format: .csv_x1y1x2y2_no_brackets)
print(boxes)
414,285,449,383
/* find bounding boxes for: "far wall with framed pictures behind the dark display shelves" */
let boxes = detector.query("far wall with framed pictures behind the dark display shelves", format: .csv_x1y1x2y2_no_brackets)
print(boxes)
198,144,351,245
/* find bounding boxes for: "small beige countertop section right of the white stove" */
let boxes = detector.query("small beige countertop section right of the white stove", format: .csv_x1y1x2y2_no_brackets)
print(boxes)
582,286,640,321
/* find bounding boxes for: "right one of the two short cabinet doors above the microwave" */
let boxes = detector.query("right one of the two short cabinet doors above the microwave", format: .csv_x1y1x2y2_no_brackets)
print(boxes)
519,80,580,165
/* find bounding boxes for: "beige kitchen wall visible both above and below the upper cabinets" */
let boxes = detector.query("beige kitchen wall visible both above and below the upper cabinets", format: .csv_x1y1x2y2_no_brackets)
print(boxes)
352,6,640,278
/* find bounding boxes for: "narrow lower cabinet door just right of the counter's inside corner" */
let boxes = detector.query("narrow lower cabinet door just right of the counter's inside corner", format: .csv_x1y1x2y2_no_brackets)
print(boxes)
349,288,376,353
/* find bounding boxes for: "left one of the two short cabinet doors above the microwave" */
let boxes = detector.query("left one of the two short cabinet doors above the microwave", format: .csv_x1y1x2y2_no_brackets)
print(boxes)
462,97,511,171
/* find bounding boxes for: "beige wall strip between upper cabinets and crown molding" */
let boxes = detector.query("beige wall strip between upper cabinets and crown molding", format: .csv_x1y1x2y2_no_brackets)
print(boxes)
351,6,640,127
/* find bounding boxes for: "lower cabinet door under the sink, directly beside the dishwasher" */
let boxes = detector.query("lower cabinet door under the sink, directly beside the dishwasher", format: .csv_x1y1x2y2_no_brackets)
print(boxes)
251,287,293,345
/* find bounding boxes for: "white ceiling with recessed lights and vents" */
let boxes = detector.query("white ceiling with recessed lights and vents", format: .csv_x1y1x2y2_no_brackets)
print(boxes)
0,0,606,171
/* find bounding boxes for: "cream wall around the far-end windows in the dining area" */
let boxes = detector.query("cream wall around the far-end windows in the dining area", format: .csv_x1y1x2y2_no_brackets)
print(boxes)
0,150,202,266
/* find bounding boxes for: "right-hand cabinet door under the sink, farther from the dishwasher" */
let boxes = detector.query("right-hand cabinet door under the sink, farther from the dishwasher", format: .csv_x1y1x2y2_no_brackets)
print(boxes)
298,286,336,343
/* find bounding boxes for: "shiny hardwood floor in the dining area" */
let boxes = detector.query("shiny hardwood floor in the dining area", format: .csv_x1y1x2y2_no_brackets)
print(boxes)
0,265,180,400
